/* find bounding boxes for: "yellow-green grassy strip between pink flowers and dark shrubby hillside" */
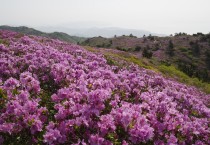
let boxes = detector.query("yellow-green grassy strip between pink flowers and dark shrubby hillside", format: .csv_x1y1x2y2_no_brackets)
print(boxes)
85,46,210,94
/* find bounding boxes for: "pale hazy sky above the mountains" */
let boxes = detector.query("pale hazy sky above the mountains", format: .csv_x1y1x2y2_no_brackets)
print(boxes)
0,0,210,34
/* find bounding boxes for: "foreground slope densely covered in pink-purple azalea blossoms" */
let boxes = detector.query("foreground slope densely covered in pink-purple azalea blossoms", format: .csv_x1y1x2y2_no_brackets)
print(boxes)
0,31,210,145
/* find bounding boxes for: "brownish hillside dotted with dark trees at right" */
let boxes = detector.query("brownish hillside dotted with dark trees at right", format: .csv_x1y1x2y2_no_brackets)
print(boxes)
81,33,210,82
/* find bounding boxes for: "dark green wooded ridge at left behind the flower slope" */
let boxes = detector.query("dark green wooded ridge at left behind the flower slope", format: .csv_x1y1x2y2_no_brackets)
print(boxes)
0,25,86,43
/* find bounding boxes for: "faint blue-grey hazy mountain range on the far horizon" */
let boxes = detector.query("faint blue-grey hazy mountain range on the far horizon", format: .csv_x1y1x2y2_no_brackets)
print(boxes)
38,27,165,38
